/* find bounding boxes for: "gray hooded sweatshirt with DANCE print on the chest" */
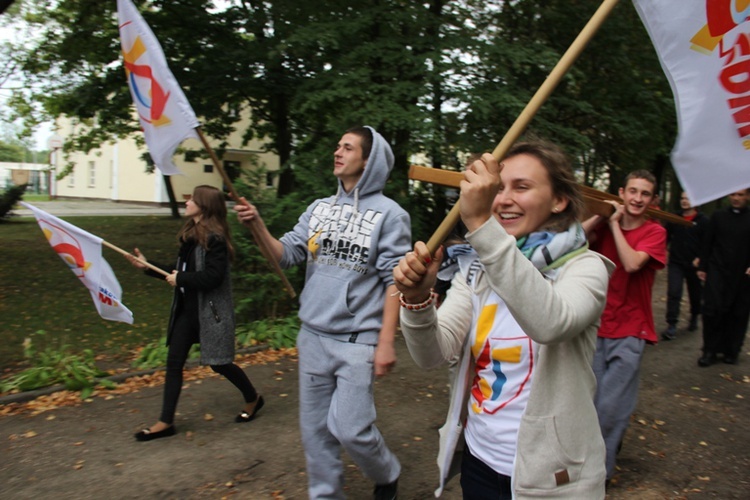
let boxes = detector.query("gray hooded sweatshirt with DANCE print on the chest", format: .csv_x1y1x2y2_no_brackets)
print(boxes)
280,127,411,345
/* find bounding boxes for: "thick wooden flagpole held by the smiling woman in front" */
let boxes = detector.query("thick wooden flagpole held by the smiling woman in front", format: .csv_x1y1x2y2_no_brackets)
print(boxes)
427,0,618,255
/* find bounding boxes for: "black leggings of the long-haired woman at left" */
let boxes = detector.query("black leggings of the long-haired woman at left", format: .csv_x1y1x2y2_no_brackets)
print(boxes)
159,314,258,424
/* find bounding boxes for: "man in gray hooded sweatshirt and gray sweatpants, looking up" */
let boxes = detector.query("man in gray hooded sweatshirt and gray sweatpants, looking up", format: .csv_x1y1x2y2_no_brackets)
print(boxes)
235,127,411,499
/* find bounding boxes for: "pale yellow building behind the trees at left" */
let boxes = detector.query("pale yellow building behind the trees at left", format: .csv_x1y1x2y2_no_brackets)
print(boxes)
50,109,279,204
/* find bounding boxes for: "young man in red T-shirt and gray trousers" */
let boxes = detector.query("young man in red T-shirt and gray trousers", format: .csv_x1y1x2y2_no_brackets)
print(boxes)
583,170,667,480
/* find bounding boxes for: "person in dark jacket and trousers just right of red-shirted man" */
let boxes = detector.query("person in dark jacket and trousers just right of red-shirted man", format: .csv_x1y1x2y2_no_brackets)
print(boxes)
661,192,708,340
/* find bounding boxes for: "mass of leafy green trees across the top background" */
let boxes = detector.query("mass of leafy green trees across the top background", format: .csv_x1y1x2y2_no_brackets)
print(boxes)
4,0,674,229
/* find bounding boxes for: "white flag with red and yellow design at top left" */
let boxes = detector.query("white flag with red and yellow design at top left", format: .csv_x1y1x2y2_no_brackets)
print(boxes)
117,0,200,175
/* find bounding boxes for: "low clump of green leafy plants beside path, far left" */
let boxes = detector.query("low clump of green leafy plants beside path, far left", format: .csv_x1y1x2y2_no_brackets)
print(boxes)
0,330,115,399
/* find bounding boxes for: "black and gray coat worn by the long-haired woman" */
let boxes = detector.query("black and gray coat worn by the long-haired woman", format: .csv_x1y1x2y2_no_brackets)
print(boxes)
147,237,235,365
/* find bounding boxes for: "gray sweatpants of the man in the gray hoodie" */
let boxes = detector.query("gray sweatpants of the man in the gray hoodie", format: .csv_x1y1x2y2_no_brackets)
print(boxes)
297,328,401,499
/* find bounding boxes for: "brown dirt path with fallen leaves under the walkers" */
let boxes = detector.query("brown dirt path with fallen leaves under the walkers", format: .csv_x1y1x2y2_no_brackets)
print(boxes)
0,272,750,500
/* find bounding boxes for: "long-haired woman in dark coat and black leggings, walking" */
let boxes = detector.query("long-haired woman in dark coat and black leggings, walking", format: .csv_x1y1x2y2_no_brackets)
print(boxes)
128,186,263,441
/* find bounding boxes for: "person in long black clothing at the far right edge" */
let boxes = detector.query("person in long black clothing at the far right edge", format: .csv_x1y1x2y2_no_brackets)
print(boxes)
698,189,750,367
